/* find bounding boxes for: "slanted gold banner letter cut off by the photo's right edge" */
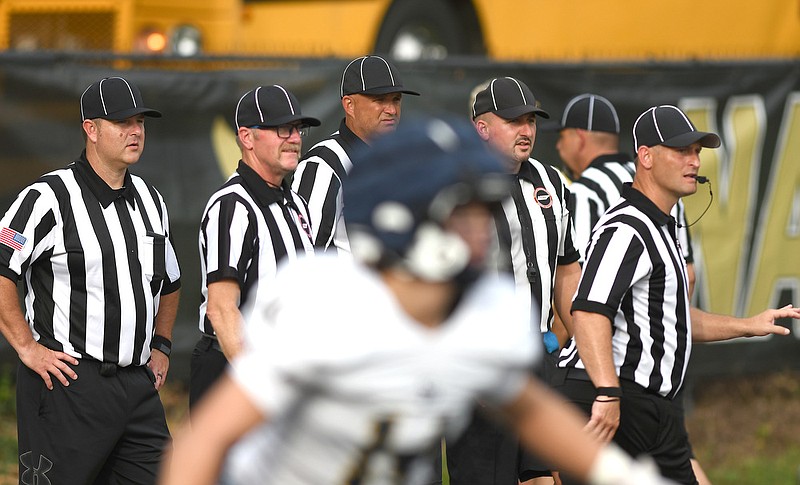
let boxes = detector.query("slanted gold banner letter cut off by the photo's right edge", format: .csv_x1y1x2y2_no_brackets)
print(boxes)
744,92,800,322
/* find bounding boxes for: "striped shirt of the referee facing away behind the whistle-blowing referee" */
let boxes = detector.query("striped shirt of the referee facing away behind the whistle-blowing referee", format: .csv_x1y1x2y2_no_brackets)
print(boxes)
569,153,694,263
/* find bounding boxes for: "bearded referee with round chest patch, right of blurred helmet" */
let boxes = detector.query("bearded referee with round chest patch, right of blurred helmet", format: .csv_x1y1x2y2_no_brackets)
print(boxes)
447,77,580,485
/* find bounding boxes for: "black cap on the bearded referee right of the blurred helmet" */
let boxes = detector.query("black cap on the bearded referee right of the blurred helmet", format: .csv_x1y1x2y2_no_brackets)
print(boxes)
472,77,550,120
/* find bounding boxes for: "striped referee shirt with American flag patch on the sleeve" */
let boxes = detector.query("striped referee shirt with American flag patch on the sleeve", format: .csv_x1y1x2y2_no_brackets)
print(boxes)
0,152,180,366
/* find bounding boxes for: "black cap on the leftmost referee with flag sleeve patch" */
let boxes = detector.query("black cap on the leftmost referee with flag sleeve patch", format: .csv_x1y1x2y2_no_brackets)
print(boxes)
81,77,161,121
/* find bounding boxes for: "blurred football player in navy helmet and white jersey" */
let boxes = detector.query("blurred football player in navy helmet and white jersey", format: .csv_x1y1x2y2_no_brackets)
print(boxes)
161,119,668,485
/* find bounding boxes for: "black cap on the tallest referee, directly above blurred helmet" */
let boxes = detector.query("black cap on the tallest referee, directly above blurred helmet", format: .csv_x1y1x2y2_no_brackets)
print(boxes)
340,56,419,97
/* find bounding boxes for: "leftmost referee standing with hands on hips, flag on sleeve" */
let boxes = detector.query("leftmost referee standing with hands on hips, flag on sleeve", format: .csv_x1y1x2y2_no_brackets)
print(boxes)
0,77,180,484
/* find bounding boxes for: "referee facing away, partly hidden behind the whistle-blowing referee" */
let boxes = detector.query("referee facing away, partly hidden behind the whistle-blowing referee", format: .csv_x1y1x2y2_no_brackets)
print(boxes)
556,93,695,297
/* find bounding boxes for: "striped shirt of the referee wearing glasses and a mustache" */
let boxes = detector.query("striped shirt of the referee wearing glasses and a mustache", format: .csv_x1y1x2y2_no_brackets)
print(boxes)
199,161,314,335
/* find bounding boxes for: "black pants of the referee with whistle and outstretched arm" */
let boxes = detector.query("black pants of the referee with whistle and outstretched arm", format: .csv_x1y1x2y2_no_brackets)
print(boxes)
555,377,697,485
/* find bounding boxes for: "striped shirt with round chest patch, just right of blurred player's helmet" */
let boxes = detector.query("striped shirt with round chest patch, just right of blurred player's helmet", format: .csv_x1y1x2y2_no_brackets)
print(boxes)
495,159,580,332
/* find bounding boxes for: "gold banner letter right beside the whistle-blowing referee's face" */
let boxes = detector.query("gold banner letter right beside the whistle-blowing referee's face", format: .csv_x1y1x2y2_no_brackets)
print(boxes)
680,96,766,314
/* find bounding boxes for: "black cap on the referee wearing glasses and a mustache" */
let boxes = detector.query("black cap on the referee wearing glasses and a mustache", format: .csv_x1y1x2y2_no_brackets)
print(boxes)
236,84,322,128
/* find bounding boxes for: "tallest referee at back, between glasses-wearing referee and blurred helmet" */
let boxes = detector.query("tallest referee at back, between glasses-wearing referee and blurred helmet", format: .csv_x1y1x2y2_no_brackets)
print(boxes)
292,56,419,254
